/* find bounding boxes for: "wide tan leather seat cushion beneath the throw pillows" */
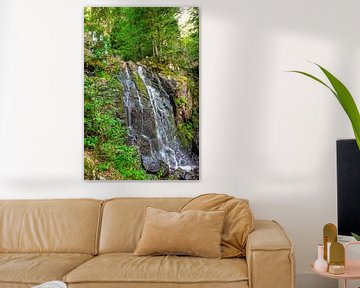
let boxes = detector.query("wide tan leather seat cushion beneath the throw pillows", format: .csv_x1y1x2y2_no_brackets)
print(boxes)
64,253,248,287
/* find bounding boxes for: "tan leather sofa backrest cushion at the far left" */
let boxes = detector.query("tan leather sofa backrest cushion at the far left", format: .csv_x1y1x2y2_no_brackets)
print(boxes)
0,199,102,254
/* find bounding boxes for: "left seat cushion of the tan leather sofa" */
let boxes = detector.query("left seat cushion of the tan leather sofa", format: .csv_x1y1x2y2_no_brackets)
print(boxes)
0,253,93,287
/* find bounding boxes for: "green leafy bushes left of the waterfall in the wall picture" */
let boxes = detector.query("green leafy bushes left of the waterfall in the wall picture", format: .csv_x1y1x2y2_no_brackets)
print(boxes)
84,71,153,180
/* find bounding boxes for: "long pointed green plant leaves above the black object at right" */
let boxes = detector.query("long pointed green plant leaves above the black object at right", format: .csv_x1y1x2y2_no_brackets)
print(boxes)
290,64,360,150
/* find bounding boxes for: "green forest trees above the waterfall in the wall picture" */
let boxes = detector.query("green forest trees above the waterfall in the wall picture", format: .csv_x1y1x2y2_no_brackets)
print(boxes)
84,7,199,70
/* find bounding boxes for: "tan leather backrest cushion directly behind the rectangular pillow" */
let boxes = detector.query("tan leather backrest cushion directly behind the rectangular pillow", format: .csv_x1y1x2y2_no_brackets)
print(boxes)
99,198,190,253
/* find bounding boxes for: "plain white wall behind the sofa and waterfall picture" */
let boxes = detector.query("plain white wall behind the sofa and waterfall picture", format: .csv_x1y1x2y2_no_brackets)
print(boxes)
0,0,360,288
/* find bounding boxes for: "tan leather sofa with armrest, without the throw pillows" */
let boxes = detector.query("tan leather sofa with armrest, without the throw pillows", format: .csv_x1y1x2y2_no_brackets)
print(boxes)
0,198,294,288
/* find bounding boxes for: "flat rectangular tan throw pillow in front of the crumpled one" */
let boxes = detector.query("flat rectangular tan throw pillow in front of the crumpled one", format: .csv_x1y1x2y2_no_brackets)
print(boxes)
134,207,225,258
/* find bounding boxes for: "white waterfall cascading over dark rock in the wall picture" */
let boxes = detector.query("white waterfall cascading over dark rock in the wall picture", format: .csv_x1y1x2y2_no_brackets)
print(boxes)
119,63,197,178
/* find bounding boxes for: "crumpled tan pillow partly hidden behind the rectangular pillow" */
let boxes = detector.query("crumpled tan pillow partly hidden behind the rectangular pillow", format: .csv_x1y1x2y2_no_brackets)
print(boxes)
181,194,254,258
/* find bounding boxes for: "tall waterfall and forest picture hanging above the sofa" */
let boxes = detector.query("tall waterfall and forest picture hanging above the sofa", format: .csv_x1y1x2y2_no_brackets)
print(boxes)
84,7,200,180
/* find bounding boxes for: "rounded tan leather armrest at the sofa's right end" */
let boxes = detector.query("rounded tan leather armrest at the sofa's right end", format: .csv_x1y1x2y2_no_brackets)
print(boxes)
246,220,295,288
